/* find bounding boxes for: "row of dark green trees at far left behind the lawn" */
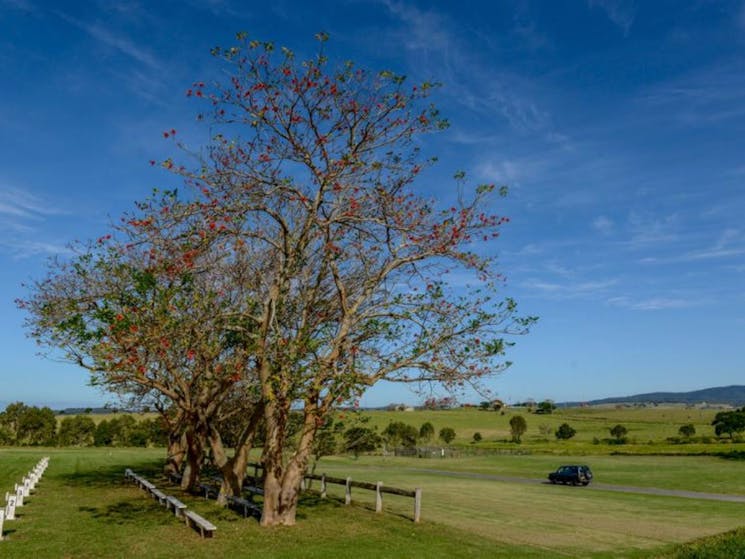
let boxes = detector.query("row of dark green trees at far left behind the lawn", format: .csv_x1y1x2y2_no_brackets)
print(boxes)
0,402,168,447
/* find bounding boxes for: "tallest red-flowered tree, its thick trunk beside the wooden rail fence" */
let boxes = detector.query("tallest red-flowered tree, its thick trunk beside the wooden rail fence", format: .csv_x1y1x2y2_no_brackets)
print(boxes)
20,34,534,525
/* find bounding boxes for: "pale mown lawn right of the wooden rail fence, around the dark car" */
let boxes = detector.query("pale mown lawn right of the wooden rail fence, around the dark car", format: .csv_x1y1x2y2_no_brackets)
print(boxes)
312,456,745,557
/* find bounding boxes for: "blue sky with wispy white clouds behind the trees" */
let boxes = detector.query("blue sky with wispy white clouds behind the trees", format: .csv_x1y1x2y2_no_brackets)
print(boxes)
0,0,745,407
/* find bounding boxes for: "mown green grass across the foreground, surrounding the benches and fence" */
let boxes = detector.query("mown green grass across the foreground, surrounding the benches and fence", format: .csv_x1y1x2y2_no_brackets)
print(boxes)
0,448,745,559
